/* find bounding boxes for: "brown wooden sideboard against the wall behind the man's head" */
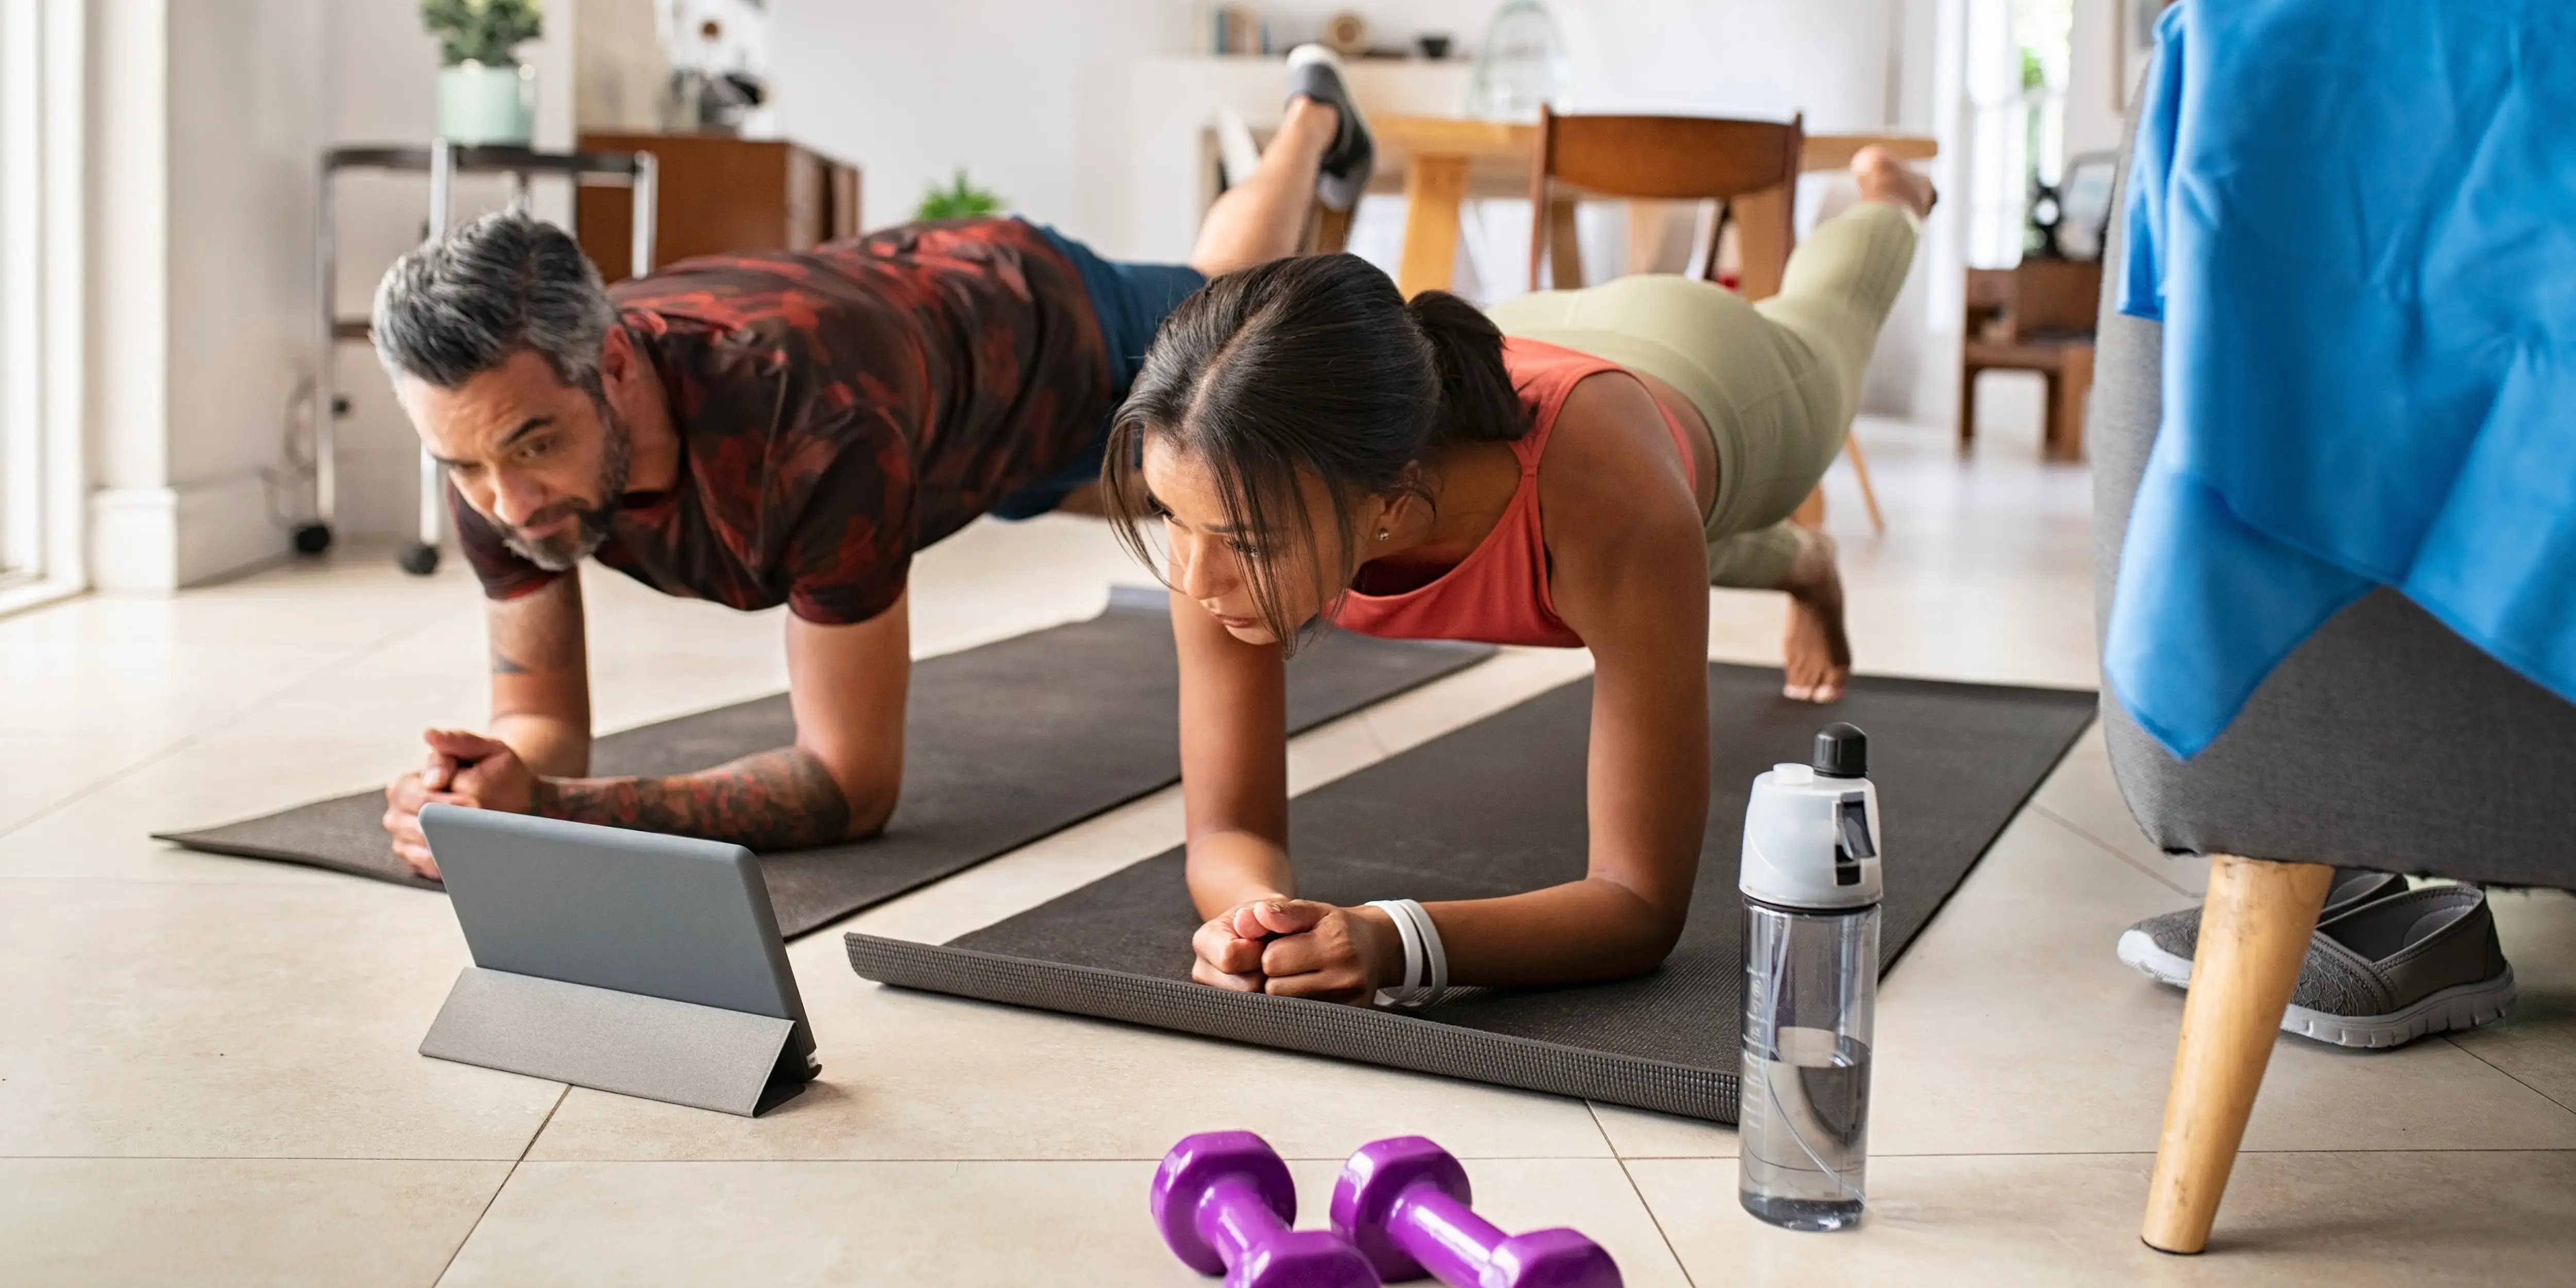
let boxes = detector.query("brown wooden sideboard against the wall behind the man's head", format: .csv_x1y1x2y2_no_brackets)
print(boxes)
574,134,860,281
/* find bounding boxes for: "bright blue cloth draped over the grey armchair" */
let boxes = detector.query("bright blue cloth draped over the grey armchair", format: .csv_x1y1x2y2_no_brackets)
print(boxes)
2102,0,2576,757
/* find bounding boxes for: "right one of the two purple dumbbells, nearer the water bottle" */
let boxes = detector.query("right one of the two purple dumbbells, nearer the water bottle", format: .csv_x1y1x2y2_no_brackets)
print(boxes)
1332,1136,1620,1288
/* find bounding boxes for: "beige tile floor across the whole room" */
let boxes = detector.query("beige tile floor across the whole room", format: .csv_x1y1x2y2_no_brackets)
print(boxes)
0,422,2576,1288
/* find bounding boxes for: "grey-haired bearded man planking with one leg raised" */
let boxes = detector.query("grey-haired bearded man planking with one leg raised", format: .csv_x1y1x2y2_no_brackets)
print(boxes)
374,49,1370,876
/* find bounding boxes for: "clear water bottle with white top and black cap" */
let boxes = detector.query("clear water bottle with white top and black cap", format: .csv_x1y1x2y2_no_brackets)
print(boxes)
1736,724,1880,1229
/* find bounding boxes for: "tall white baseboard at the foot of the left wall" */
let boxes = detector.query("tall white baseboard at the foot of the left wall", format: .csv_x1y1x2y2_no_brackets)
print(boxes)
90,474,289,590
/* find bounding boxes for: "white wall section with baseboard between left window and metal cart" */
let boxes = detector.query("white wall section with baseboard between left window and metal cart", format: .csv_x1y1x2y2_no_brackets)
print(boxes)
90,0,322,590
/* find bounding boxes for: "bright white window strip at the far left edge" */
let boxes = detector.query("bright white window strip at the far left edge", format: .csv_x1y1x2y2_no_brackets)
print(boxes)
0,0,82,608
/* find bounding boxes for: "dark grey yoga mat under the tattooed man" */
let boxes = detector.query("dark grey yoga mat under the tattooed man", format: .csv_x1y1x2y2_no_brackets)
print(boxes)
160,590,1494,938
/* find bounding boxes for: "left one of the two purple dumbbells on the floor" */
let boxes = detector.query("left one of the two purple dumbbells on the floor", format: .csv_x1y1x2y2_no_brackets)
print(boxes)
1154,1131,1378,1288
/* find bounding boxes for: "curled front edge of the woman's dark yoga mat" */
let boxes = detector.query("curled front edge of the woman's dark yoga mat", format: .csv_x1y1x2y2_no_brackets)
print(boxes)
842,933,1736,1123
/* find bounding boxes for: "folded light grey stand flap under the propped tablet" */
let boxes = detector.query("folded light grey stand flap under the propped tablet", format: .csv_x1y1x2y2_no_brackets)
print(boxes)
420,966,806,1118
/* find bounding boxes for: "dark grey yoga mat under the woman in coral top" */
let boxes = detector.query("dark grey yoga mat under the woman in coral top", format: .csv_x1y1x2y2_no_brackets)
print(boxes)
848,665,2094,1123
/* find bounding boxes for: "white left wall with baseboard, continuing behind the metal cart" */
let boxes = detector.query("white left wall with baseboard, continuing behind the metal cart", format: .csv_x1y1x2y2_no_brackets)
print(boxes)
88,0,572,590
